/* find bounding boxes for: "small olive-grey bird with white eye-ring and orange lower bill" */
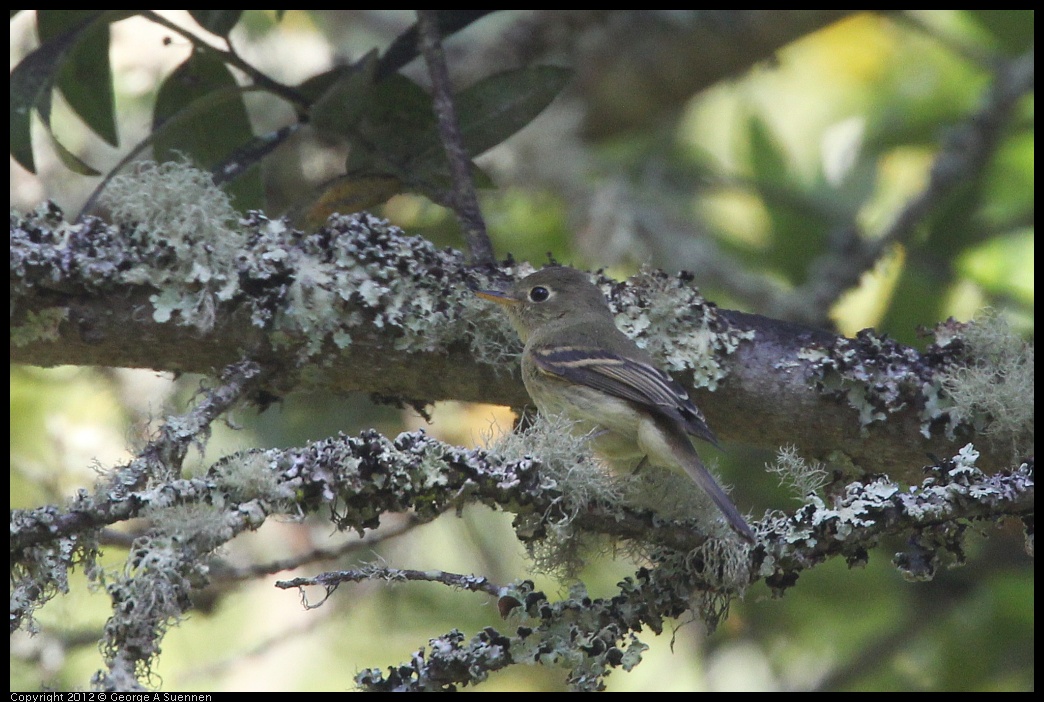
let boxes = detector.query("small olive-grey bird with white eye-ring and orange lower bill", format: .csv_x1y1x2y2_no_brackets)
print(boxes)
474,265,756,544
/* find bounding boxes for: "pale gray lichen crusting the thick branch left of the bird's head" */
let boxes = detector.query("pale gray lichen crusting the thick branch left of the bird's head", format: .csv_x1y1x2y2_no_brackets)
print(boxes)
11,163,496,360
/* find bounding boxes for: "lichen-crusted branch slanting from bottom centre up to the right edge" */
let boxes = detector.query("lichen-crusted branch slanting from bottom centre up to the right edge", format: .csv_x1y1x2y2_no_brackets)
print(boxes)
348,450,1034,692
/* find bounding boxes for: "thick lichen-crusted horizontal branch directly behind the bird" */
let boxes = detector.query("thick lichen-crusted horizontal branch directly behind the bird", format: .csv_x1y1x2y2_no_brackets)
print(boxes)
10,192,1031,478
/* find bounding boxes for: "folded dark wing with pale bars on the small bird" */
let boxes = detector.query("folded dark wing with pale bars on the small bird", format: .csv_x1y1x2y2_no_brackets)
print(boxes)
531,345,717,446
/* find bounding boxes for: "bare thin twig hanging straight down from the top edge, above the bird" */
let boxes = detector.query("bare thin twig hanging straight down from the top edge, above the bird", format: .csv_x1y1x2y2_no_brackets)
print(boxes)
417,9,495,264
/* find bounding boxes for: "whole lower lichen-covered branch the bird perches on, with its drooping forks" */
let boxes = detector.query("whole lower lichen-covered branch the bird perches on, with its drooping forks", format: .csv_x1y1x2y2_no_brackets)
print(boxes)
10,401,1034,689
